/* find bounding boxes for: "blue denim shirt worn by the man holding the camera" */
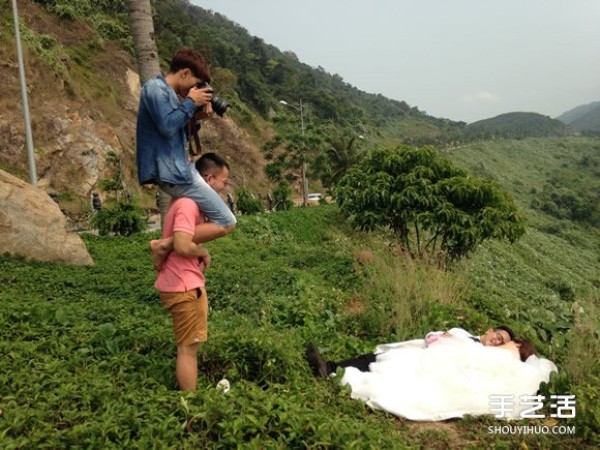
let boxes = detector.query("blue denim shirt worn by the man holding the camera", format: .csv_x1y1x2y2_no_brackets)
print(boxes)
136,76,196,185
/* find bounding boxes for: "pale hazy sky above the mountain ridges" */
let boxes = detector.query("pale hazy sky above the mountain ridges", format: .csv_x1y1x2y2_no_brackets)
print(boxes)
192,0,600,122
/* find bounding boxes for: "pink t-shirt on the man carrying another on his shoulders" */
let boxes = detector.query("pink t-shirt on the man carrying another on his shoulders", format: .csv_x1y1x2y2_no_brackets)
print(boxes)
154,197,204,292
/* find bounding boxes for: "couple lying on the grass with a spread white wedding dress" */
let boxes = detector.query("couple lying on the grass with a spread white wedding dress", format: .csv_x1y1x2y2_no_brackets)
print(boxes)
306,327,558,421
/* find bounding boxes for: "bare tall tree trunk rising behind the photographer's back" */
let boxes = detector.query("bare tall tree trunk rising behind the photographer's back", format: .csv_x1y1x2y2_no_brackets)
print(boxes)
127,0,170,226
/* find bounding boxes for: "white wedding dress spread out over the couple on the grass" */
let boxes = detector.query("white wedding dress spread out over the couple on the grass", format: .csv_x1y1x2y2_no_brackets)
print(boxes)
341,339,557,421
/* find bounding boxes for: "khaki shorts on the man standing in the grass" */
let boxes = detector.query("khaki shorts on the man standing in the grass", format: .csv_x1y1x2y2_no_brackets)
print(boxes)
159,288,208,345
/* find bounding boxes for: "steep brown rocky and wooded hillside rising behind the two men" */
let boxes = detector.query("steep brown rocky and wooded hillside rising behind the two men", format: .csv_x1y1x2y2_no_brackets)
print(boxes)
0,0,596,205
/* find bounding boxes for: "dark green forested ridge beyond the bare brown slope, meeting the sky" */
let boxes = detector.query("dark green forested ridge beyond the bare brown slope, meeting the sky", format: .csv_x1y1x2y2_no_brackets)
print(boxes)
149,0,464,143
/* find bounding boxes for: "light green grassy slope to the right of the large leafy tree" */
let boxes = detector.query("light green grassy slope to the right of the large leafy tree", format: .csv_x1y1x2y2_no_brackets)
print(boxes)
449,138,600,302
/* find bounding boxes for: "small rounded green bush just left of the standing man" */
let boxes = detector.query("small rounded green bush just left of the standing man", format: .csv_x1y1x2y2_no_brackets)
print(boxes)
90,200,148,236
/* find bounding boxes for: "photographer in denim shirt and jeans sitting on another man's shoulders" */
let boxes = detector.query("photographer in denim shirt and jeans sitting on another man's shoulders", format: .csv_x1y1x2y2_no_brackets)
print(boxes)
136,49,236,268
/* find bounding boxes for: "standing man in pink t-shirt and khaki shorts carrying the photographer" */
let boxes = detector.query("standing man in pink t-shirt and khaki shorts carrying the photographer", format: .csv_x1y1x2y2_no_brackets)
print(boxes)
154,153,229,391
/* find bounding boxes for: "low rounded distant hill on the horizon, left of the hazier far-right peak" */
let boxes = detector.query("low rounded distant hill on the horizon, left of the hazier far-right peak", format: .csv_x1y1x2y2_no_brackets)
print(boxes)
465,112,573,139
